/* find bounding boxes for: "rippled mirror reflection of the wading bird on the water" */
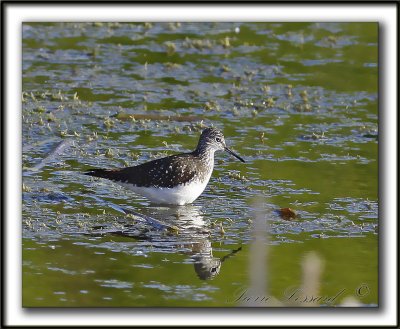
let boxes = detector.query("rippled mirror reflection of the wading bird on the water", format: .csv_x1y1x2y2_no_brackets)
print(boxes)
104,205,241,280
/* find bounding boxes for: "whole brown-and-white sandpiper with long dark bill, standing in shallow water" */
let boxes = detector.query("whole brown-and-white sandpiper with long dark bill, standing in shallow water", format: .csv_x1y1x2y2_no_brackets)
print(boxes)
85,128,245,205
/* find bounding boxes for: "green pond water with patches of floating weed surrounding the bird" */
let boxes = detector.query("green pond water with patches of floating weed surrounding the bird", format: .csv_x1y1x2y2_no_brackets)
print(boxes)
22,23,378,307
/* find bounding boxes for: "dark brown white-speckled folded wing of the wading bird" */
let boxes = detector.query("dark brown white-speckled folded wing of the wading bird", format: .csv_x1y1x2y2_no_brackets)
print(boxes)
85,154,196,188
